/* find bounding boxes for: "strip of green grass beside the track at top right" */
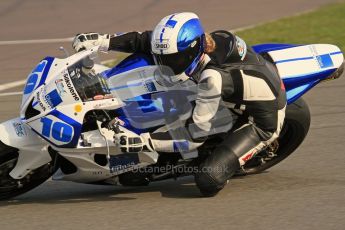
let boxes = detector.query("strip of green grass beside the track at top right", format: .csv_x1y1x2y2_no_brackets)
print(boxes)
236,2,345,51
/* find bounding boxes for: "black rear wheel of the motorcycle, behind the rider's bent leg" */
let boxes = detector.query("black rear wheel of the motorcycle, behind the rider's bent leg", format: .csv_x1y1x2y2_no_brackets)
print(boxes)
238,98,310,175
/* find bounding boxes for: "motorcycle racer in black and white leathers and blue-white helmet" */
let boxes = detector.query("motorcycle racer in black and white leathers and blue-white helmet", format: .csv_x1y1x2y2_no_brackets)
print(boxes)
73,13,286,196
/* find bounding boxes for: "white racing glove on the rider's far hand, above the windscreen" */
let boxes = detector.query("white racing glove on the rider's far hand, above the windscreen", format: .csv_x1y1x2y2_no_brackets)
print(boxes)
72,33,110,52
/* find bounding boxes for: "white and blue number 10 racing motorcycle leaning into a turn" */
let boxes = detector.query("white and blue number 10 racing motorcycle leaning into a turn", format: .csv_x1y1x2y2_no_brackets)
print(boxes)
0,44,344,199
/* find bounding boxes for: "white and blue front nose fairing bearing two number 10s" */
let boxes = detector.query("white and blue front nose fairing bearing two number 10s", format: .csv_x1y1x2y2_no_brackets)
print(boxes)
20,51,118,148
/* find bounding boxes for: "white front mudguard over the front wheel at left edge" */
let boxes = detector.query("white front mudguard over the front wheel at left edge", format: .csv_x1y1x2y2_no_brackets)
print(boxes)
0,118,52,179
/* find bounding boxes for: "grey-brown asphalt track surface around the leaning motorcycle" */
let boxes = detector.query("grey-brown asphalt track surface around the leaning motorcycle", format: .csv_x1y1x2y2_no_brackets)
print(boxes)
0,0,345,230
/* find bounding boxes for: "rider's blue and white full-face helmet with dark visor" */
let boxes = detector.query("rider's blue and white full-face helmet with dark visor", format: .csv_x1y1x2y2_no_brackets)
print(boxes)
151,13,205,82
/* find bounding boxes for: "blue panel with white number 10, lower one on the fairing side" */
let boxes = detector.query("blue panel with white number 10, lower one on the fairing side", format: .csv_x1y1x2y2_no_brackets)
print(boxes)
41,117,73,143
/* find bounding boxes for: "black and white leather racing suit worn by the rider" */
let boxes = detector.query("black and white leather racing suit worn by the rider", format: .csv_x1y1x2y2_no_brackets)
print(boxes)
109,31,286,188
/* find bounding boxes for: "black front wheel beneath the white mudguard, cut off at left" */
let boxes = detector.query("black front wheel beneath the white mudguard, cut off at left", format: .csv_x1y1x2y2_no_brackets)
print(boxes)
0,141,53,200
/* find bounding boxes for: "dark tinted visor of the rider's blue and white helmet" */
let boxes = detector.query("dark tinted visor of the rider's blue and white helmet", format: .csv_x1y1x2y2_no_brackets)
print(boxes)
153,38,201,75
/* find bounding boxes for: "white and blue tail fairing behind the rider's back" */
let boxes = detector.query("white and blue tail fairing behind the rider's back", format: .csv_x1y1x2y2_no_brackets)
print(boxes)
253,44,344,104
